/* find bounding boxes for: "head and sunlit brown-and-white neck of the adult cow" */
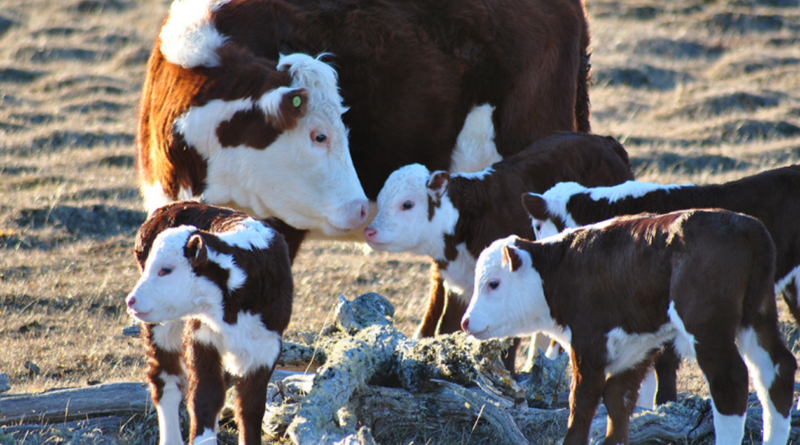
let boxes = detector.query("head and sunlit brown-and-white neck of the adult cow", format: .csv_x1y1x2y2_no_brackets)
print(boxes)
139,0,367,235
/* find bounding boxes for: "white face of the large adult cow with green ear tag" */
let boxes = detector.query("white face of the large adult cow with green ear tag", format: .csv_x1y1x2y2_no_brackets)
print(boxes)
184,54,368,235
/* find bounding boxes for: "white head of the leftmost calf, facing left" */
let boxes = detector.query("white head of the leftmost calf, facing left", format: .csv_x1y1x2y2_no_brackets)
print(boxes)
125,226,234,323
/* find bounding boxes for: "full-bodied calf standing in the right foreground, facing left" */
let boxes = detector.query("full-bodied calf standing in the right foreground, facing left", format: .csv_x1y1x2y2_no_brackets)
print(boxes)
462,210,797,445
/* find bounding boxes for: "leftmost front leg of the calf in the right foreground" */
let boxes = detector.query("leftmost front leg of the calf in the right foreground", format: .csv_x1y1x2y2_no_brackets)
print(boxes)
563,350,605,445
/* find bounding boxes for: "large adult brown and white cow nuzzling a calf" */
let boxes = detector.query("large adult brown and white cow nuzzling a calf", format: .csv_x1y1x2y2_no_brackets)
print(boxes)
138,0,589,247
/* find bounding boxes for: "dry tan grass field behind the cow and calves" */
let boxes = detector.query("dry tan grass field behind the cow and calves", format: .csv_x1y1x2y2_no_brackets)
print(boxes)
0,0,800,443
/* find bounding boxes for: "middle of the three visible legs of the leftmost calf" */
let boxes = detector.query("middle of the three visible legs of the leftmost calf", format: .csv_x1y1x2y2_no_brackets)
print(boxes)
185,321,227,445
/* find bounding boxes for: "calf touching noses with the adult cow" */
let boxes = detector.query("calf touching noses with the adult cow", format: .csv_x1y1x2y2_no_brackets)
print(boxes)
364,133,633,363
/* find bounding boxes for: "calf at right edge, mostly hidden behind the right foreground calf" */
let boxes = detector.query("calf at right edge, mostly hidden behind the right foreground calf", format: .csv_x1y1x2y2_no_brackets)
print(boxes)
522,165,800,403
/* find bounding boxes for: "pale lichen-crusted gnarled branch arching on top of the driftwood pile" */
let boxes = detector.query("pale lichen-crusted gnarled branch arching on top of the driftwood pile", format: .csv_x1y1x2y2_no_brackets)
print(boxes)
265,294,524,444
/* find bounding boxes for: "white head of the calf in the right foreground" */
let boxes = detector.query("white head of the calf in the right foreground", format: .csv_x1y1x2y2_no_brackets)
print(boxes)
461,235,550,340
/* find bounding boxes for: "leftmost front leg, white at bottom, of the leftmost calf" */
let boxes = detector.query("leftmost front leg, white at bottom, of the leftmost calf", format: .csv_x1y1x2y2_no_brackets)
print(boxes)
142,321,186,445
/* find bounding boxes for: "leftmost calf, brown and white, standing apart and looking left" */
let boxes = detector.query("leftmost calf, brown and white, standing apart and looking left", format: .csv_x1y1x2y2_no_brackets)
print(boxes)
126,202,292,445
